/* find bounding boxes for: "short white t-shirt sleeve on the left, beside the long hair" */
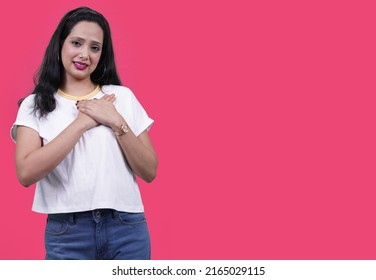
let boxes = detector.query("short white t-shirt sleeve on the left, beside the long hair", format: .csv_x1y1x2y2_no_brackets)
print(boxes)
10,95,39,142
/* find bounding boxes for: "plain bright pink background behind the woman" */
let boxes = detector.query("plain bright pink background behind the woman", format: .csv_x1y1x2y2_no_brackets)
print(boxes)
0,0,376,259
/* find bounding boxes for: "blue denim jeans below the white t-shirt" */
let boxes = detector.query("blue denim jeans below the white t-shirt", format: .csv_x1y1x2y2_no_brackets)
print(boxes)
45,209,150,260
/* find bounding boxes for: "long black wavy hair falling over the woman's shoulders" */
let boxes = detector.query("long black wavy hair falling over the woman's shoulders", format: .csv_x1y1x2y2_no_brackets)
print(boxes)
18,7,121,117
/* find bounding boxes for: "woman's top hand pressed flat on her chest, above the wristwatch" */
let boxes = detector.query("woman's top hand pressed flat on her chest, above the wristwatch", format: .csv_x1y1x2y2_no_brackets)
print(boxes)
77,94,124,127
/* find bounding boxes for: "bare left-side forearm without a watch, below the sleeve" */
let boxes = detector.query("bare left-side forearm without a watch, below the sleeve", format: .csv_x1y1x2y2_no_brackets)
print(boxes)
16,121,86,186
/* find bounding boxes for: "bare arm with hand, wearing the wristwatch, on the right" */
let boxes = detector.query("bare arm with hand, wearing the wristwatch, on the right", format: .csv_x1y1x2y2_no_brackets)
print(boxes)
78,97,158,182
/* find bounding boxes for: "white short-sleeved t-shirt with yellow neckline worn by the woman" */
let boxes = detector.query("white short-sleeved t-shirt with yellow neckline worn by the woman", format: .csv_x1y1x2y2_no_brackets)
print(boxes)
11,85,153,214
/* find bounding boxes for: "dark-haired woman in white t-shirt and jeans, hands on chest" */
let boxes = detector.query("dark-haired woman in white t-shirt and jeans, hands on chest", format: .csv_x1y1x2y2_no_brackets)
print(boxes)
12,7,158,259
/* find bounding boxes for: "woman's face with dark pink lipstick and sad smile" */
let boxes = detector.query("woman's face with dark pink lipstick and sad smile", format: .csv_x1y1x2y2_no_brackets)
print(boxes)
61,21,103,83
